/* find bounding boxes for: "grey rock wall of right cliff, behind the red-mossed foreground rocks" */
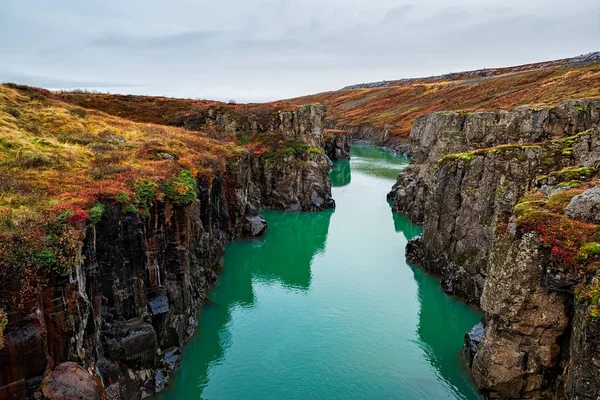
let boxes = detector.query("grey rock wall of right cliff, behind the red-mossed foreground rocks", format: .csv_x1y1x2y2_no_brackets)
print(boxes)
388,101,600,305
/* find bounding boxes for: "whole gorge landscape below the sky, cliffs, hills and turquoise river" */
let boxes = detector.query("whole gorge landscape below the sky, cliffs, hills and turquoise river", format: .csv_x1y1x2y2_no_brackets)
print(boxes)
0,53,600,400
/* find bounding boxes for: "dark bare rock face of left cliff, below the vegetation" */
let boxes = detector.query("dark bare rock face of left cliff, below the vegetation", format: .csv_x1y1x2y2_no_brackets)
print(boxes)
0,106,335,399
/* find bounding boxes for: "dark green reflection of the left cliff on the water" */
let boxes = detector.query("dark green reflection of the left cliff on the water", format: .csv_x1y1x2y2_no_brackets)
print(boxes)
159,210,334,398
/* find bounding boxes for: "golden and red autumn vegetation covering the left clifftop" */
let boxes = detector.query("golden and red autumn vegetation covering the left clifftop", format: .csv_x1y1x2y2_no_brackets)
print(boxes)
0,84,320,324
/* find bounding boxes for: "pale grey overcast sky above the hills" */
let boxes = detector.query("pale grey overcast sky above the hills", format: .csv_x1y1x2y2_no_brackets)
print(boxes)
0,0,600,102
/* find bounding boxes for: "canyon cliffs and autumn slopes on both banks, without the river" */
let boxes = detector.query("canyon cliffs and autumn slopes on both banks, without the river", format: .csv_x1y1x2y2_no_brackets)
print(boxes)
0,53,600,399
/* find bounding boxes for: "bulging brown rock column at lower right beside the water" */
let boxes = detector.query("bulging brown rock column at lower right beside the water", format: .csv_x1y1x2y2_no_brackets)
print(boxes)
472,233,570,399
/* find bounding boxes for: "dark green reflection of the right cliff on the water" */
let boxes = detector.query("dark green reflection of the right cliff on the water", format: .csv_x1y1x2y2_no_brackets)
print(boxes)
394,214,482,399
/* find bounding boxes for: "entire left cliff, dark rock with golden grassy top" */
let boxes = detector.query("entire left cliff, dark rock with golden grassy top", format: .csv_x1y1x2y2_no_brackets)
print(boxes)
0,85,344,399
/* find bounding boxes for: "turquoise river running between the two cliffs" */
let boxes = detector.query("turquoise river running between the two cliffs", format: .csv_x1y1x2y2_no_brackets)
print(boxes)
163,146,480,400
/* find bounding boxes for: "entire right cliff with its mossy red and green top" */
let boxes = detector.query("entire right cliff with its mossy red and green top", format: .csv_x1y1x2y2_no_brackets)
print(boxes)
388,100,600,399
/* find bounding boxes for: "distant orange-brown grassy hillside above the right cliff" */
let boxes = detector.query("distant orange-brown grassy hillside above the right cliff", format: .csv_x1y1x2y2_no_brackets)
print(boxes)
290,64,600,140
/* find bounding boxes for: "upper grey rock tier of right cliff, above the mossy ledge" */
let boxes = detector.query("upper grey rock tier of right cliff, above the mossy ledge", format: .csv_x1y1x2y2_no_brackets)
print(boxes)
388,100,600,224
